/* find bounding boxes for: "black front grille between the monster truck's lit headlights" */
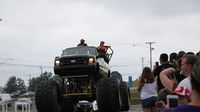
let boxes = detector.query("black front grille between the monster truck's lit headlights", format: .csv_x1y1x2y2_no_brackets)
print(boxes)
62,57,87,65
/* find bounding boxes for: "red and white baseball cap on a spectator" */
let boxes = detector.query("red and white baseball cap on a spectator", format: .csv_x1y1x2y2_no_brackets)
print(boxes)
172,86,190,96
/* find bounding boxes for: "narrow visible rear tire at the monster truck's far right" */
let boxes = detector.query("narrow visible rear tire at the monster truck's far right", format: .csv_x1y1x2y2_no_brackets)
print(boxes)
120,81,131,111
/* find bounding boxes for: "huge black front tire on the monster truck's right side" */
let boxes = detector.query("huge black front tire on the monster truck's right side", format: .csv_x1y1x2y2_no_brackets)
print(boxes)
96,77,121,112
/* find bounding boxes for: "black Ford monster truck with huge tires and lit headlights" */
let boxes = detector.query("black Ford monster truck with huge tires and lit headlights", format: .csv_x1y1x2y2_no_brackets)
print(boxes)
35,46,130,112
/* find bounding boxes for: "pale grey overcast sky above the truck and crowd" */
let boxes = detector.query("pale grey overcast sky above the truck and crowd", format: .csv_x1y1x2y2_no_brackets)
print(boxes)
0,0,200,86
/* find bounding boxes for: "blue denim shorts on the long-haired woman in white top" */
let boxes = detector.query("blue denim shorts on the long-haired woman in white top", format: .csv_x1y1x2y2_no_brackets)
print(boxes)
141,96,158,108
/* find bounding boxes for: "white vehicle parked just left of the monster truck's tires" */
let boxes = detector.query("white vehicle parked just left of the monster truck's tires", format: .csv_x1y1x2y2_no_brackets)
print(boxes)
15,98,32,110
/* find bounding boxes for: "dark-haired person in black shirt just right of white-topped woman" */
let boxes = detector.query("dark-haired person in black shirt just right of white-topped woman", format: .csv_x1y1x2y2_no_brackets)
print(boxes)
153,53,172,92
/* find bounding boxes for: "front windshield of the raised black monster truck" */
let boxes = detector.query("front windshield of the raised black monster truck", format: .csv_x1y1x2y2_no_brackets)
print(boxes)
62,47,97,56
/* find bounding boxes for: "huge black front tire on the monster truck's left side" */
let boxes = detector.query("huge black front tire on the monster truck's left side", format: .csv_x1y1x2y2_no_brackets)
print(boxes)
35,81,61,112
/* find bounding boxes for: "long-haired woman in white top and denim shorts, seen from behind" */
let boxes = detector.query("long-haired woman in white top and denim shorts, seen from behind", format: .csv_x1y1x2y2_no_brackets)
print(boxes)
137,67,157,112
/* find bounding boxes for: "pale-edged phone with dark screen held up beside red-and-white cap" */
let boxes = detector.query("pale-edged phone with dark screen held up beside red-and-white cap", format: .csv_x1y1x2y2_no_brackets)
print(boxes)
167,95,179,108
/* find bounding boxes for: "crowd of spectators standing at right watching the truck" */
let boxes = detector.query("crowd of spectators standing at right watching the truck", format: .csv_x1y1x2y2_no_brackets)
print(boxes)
138,51,200,112
